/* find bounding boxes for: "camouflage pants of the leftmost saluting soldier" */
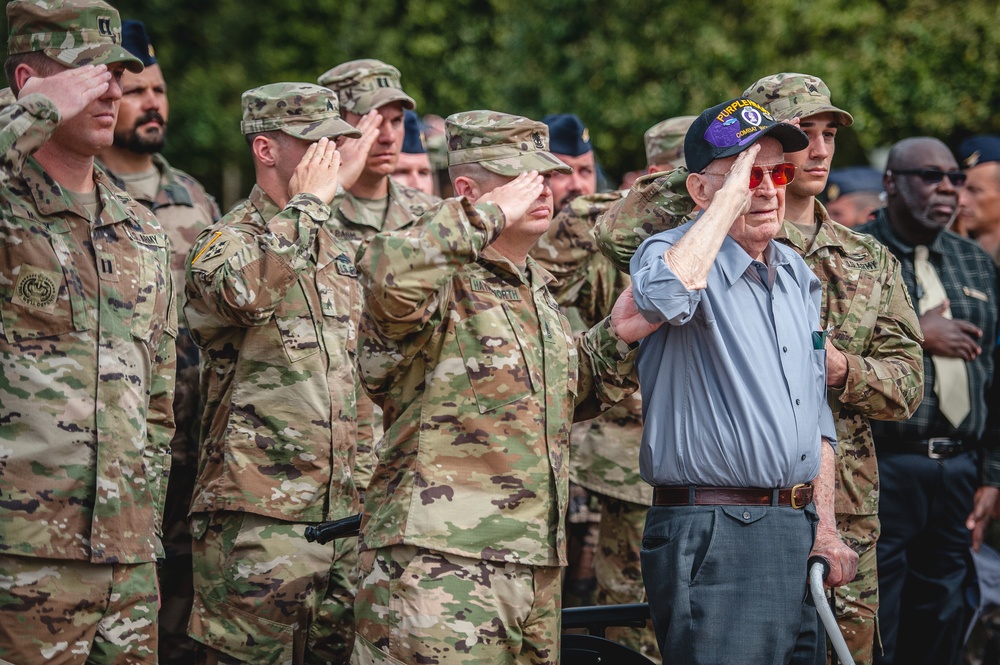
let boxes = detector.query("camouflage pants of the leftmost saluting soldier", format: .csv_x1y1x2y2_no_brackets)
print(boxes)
0,555,157,665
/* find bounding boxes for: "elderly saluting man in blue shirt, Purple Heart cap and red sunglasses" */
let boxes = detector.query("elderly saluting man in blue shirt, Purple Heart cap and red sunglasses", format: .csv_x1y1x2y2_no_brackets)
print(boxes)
631,98,857,663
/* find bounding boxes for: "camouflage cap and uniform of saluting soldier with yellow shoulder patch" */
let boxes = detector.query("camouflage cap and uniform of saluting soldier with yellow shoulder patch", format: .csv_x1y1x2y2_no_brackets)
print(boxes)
186,83,361,663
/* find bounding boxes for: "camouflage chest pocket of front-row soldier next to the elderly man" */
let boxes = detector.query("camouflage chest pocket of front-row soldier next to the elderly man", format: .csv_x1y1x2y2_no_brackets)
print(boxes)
456,303,533,413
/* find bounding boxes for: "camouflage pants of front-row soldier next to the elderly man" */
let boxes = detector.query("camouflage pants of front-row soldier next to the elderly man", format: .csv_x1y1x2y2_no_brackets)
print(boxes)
351,545,560,665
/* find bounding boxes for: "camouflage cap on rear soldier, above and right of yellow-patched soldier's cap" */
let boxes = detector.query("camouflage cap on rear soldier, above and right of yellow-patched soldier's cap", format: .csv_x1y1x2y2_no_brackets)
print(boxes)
319,58,417,115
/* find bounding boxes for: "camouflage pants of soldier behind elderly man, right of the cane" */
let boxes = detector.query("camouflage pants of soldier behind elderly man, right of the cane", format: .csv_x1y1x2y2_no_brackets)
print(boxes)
827,514,879,665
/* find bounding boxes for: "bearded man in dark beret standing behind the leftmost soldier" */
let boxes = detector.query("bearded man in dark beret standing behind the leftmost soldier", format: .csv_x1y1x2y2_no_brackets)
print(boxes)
99,20,219,664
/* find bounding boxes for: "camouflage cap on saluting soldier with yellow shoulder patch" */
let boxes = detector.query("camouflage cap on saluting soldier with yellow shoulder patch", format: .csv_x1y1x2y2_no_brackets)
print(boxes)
240,83,361,141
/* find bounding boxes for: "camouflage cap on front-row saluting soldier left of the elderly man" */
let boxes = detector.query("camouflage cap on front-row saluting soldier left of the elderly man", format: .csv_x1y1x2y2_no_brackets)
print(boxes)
444,111,573,176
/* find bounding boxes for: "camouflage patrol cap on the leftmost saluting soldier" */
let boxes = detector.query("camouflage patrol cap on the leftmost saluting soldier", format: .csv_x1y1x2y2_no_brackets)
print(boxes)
7,0,143,73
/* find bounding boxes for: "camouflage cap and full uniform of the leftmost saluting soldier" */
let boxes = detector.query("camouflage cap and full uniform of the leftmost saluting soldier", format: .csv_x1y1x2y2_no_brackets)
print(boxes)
0,0,176,663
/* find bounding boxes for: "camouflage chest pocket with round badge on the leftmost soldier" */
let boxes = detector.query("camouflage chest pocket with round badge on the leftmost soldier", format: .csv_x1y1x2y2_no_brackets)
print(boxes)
0,232,87,343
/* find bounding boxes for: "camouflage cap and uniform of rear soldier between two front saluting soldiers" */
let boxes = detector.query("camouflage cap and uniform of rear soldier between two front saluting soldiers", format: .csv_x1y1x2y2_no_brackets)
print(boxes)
318,59,441,497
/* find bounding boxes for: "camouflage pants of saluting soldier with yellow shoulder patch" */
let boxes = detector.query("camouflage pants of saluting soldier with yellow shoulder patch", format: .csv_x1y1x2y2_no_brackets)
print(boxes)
188,512,357,665
